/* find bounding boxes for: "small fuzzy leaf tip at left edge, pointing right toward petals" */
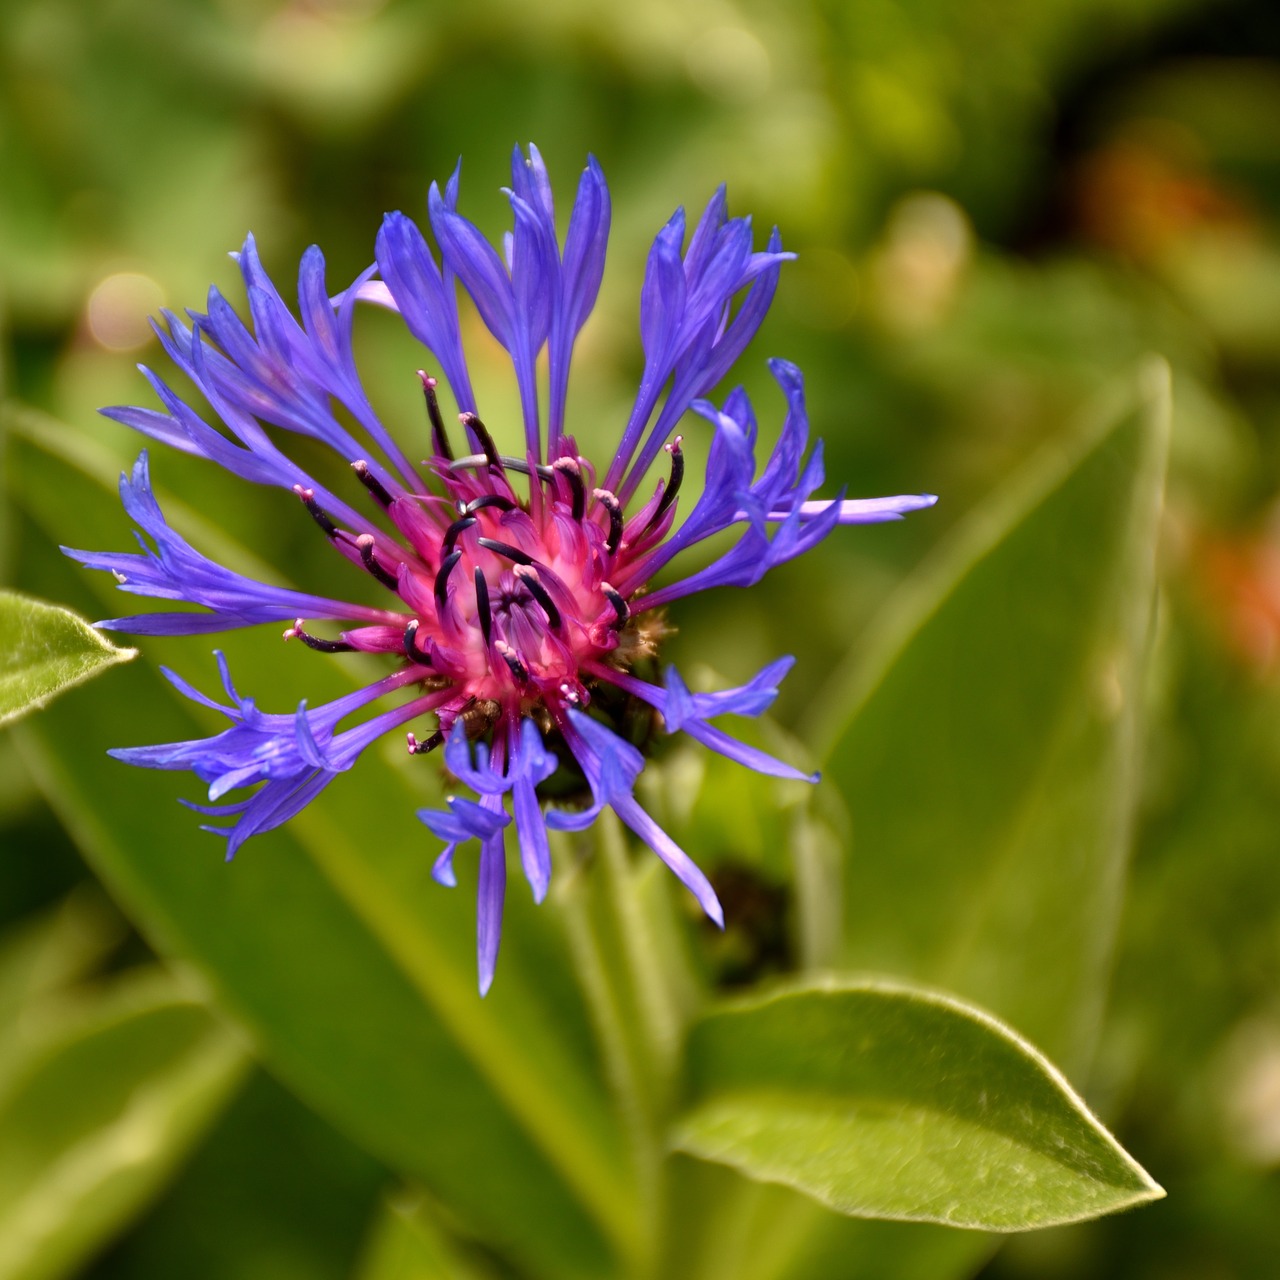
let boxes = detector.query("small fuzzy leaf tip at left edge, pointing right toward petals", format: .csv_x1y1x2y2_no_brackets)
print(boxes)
0,591,137,724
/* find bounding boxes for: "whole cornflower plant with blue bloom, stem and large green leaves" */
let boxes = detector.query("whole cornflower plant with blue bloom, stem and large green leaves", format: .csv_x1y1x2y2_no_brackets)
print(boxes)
18,147,1167,1280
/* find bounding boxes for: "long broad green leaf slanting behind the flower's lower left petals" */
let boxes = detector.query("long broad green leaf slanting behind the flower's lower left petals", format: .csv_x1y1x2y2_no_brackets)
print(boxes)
5,416,639,1277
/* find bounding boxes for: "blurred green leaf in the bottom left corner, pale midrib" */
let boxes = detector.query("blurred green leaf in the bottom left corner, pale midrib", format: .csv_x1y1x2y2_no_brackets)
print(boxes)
0,974,248,1280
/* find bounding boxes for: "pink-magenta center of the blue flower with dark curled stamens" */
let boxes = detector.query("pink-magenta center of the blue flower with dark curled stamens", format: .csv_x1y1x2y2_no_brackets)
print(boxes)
320,424,680,750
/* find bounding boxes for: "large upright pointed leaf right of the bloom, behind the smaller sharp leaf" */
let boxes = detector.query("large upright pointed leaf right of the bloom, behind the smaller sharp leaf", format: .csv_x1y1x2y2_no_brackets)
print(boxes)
671,369,1167,1280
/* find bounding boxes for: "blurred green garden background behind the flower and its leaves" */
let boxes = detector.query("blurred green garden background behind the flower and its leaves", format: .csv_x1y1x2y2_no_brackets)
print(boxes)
0,0,1280,1280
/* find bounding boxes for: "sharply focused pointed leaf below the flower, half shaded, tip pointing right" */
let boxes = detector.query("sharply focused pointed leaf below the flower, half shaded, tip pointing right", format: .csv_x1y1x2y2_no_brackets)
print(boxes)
675,979,1164,1231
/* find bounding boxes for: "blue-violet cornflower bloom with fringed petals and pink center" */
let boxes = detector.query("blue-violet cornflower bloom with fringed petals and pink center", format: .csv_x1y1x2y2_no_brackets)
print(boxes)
67,146,934,993
